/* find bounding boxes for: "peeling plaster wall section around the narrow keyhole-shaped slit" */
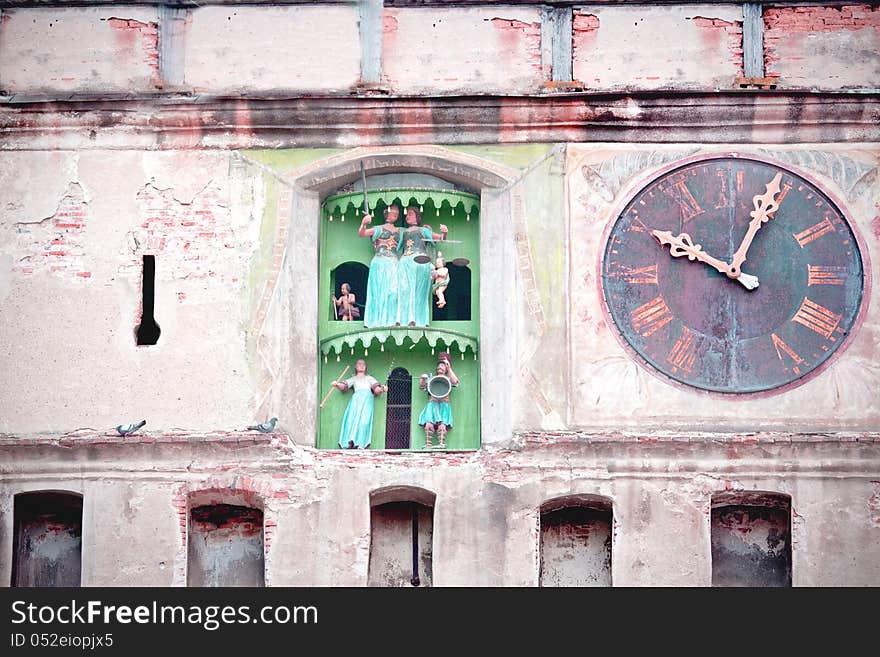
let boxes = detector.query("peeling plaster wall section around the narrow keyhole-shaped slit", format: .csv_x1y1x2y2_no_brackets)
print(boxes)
0,152,262,433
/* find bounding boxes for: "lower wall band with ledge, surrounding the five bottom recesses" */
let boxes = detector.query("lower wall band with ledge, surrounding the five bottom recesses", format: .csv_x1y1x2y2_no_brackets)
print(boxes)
0,432,880,586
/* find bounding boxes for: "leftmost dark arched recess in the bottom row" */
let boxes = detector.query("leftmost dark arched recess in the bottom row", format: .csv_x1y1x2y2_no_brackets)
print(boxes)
12,493,82,587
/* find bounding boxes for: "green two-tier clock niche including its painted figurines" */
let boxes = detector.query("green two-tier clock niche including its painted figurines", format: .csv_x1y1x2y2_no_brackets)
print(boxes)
308,153,516,450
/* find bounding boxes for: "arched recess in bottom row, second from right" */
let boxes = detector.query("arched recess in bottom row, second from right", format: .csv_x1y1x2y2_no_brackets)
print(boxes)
538,495,614,587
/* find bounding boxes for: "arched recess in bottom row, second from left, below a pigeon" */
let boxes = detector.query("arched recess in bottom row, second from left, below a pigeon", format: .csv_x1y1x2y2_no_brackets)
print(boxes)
186,504,265,586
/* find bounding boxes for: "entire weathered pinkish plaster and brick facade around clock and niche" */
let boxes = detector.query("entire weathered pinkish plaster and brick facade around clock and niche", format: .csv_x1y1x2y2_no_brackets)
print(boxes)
0,3,880,586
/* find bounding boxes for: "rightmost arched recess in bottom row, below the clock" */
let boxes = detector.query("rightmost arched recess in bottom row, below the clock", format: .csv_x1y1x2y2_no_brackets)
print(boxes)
711,491,792,587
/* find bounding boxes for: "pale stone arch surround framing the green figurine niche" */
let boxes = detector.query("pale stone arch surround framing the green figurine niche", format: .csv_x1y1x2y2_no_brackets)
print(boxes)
252,146,521,445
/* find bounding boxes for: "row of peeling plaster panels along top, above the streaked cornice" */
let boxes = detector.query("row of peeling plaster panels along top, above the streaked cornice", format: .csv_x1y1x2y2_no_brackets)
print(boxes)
0,3,880,95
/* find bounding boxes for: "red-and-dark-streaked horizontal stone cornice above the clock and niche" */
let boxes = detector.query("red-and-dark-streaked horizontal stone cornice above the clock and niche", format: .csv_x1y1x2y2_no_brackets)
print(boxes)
0,92,880,150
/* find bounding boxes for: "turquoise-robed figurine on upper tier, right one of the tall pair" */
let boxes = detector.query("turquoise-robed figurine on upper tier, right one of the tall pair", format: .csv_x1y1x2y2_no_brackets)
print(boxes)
395,205,449,326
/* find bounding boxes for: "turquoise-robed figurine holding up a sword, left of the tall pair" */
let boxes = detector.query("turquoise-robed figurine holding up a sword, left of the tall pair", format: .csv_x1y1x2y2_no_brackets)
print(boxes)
358,205,400,327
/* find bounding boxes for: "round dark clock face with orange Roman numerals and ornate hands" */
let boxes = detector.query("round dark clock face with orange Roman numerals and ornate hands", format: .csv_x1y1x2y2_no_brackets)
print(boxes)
602,157,864,393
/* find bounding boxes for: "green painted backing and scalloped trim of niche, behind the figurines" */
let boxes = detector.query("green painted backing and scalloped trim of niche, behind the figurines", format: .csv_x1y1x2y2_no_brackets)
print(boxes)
317,187,480,451
